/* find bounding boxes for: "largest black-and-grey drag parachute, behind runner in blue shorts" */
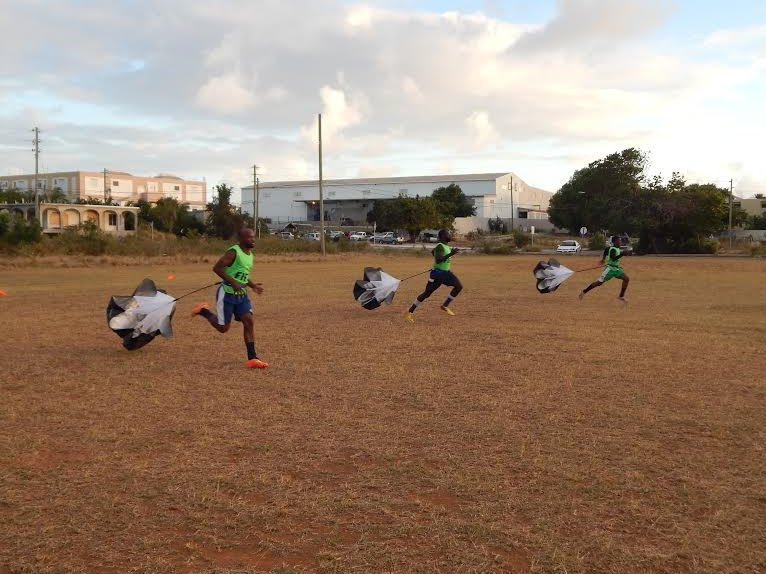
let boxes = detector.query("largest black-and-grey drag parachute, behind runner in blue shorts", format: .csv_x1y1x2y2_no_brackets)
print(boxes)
106,279,176,351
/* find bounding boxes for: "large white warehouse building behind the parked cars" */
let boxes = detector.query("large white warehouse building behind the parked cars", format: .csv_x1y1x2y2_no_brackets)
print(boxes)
242,173,553,233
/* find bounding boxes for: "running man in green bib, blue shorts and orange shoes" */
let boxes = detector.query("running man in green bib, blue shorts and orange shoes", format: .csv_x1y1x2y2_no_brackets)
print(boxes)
192,228,269,369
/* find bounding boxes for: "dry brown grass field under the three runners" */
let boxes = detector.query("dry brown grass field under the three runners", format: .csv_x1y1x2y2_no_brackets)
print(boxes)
0,253,766,574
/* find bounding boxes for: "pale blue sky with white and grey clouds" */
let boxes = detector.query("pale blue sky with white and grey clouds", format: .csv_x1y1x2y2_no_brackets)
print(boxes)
0,0,766,202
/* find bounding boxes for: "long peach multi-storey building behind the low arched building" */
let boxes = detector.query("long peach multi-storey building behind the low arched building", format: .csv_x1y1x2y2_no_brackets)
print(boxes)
0,170,207,210
